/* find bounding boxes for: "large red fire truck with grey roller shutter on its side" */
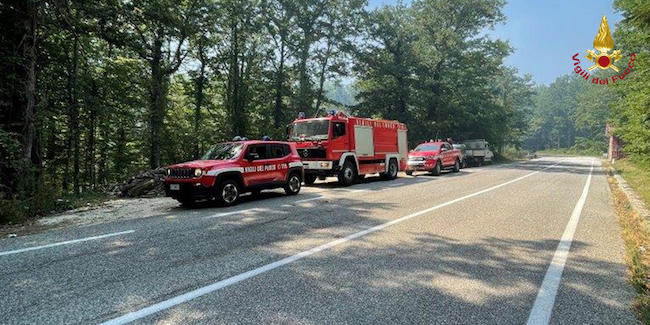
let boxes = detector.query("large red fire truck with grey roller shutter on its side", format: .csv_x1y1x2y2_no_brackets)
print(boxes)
289,111,408,186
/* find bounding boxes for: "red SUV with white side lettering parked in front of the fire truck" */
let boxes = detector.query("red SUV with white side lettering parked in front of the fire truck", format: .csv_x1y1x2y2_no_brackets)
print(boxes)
164,140,304,206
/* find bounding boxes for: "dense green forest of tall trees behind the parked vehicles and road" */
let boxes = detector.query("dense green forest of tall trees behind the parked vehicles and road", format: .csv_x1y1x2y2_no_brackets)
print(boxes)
0,0,650,221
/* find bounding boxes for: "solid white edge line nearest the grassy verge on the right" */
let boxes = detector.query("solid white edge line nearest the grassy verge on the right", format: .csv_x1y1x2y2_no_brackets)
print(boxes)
526,160,594,325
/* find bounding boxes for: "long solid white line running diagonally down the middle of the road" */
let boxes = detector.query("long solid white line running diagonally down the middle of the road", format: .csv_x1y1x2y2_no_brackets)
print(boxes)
100,163,559,325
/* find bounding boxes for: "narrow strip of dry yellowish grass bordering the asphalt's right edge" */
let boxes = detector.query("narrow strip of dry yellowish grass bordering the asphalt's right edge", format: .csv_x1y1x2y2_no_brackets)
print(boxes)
606,162,650,325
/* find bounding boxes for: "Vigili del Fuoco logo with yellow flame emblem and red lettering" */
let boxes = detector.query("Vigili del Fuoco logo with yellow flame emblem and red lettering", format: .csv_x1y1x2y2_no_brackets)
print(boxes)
573,15,636,85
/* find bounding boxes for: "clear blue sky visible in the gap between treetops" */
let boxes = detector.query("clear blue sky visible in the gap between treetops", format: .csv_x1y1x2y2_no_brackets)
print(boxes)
370,0,625,84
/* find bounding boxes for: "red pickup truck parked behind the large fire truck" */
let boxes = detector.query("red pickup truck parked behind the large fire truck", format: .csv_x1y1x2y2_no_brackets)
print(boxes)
406,141,463,176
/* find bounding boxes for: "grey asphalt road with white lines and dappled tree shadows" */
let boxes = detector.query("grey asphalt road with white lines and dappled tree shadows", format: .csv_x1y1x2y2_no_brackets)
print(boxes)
0,157,636,324
